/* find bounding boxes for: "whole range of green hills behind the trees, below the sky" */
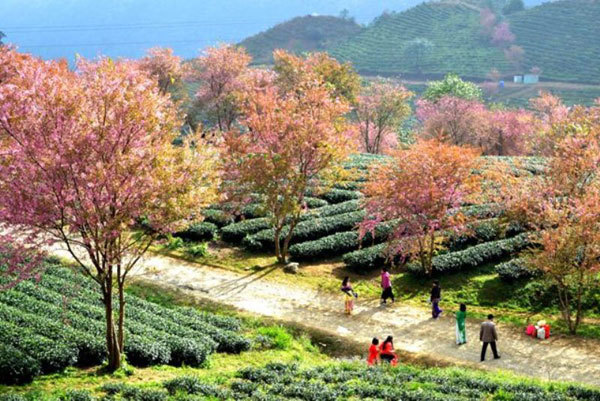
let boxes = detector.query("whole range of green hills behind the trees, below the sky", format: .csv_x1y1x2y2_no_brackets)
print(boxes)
241,0,600,84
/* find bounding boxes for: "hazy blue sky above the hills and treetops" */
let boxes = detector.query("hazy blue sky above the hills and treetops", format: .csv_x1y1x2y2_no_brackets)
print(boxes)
0,0,538,61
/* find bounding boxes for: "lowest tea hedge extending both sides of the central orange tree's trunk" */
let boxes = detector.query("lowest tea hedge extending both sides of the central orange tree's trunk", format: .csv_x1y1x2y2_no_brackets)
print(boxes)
243,210,365,251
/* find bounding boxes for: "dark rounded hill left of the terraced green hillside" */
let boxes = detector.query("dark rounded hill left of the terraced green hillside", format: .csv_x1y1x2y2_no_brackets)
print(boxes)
240,15,362,64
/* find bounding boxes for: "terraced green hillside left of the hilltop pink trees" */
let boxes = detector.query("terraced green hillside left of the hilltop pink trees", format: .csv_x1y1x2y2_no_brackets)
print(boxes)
331,2,508,77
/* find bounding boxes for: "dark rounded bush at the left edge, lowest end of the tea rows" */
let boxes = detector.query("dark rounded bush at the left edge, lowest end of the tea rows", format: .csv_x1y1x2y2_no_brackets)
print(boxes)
0,343,41,385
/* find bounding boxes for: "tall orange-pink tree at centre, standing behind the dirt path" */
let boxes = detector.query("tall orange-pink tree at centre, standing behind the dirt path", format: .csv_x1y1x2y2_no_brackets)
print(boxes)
222,50,355,262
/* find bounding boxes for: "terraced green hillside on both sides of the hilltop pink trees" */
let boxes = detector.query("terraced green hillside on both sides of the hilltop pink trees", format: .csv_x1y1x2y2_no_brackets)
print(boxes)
331,0,600,83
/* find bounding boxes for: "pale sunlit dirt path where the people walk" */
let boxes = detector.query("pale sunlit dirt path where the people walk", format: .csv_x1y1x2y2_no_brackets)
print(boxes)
50,248,600,386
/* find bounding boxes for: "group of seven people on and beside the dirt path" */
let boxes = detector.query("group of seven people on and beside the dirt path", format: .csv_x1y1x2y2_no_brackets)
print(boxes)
342,268,500,365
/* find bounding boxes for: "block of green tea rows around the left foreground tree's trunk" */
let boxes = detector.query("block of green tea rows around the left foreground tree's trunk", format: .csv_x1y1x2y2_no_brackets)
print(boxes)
0,267,250,383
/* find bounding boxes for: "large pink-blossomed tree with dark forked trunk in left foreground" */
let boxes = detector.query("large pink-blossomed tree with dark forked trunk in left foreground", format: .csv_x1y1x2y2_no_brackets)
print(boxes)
0,50,215,370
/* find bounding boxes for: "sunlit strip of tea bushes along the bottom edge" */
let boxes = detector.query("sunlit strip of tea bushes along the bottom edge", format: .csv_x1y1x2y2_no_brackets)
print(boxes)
0,363,600,401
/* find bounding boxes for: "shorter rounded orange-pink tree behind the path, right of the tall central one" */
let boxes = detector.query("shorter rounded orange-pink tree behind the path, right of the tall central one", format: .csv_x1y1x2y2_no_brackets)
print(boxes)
360,140,480,275
